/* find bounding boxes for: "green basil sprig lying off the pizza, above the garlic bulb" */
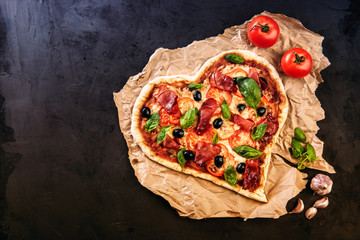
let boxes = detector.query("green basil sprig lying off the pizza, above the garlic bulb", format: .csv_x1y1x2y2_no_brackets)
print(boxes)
290,127,319,170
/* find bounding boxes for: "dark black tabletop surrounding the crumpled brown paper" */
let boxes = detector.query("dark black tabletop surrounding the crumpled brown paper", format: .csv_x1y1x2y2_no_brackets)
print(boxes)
0,0,360,239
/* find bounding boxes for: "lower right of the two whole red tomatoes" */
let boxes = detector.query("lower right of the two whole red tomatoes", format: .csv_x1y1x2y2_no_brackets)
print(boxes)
281,48,312,78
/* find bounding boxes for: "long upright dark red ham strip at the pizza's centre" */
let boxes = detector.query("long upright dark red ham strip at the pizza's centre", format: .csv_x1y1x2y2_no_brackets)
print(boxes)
196,98,219,135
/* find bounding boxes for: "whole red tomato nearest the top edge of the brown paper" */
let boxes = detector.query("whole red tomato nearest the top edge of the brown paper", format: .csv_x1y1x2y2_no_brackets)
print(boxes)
247,16,280,48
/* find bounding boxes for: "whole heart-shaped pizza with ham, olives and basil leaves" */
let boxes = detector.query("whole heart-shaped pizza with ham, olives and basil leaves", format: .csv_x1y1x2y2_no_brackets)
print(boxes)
131,50,288,202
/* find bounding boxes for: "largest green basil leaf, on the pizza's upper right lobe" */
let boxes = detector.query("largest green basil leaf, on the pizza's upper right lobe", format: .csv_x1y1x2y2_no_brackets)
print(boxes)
238,77,261,116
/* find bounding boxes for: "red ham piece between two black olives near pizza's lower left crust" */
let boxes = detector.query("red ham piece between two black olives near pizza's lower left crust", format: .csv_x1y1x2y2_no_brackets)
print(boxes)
194,141,221,165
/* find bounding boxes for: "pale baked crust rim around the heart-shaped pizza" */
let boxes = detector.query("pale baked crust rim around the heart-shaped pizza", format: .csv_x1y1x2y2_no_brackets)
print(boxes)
131,50,288,202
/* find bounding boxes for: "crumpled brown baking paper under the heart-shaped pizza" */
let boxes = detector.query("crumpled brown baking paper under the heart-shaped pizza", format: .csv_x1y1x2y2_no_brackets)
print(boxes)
114,12,335,219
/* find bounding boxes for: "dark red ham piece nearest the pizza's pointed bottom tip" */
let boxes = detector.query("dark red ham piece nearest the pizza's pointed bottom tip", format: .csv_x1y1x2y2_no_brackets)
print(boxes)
243,160,260,191
